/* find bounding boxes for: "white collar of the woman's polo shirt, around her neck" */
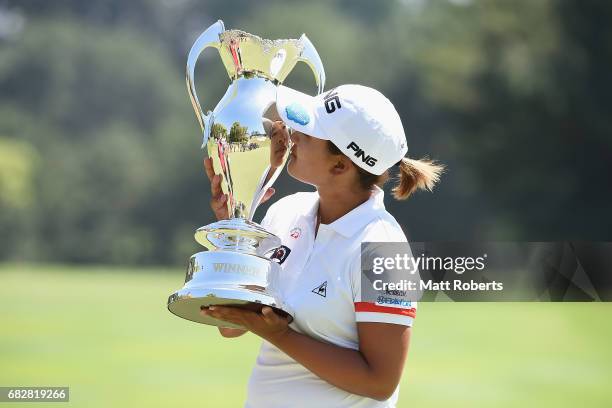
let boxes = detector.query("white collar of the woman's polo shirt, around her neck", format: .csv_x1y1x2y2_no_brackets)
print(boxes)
305,186,385,238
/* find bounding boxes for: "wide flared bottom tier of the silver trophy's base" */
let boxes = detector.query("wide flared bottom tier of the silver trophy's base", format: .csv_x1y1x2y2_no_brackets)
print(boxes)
168,287,293,329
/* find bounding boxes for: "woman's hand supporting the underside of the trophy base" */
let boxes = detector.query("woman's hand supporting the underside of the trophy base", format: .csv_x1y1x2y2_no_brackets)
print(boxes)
200,306,289,342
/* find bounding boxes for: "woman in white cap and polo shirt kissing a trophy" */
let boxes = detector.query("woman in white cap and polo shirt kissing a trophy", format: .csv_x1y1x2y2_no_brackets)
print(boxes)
202,85,443,408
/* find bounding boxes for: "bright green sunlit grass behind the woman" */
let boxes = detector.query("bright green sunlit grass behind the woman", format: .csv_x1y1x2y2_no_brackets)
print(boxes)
0,265,612,407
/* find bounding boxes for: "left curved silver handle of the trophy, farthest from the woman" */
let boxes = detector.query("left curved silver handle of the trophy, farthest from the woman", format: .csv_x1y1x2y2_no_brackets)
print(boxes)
185,20,225,147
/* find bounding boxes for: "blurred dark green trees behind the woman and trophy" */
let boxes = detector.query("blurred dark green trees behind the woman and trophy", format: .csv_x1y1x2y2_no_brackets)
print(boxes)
0,0,612,264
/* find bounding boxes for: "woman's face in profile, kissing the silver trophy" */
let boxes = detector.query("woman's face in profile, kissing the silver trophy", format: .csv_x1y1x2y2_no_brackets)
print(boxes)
287,131,337,186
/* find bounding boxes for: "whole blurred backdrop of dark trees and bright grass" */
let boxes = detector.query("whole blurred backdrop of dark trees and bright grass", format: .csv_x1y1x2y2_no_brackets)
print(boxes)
0,0,612,407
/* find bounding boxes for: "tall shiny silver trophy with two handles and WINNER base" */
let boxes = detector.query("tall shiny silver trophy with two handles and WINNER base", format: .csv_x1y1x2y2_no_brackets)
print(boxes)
168,20,325,327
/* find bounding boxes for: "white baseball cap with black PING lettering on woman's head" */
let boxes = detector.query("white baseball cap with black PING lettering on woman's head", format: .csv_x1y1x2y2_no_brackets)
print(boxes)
276,85,408,175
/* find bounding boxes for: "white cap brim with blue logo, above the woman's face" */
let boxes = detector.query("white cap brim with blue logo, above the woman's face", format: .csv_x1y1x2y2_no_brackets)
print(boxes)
276,85,329,140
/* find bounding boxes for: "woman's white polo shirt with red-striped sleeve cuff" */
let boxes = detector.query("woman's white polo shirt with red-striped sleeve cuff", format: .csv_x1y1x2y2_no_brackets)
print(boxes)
245,189,416,408
